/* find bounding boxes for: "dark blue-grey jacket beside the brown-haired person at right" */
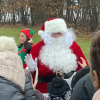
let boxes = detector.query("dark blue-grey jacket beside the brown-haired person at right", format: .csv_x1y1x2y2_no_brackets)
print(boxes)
70,73,95,100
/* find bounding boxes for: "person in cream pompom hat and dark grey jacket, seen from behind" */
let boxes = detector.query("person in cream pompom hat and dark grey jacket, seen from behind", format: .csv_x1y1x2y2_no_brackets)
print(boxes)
0,36,26,100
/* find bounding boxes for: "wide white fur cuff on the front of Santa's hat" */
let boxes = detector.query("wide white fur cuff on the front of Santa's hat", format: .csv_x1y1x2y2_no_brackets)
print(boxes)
44,18,67,33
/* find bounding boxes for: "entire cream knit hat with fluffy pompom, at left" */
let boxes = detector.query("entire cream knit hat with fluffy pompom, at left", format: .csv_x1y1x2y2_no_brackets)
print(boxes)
0,36,25,90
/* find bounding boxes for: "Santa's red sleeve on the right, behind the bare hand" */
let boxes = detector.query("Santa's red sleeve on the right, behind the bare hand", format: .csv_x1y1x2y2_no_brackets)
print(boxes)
70,41,88,71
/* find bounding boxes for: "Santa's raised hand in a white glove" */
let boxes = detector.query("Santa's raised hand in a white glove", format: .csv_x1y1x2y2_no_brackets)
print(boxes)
24,54,37,71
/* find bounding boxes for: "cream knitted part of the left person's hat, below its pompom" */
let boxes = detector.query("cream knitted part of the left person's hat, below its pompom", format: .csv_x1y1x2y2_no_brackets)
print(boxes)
0,51,25,90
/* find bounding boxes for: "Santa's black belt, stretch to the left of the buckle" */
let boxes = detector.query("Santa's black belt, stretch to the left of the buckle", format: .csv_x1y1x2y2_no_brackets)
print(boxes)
38,75,56,83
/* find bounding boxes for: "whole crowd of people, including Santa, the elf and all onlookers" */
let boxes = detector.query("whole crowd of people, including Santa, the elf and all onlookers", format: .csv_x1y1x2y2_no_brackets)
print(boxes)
0,18,100,100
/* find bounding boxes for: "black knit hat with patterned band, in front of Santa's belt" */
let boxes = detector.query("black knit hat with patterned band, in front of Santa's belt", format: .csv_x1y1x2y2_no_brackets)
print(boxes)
47,77,71,100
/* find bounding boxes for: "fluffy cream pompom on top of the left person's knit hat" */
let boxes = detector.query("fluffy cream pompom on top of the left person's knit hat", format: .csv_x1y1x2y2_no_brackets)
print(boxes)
0,36,18,53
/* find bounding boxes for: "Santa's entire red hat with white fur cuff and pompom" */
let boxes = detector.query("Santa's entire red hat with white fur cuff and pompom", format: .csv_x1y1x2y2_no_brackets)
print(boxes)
38,18,67,36
